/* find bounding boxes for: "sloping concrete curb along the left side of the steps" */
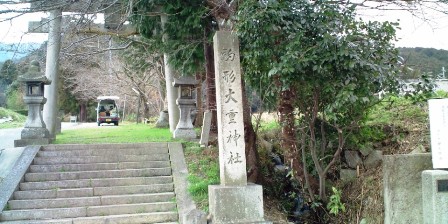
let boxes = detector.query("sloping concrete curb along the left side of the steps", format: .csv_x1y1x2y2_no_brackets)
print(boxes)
0,146,41,214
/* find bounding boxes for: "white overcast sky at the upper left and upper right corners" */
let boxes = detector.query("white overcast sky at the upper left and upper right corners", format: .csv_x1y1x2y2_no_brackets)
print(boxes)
0,2,448,50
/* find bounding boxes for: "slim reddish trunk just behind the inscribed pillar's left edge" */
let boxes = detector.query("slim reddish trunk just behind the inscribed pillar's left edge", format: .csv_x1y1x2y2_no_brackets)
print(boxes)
204,25,218,135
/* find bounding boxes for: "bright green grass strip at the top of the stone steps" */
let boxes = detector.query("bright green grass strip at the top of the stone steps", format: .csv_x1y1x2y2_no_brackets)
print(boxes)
54,123,175,144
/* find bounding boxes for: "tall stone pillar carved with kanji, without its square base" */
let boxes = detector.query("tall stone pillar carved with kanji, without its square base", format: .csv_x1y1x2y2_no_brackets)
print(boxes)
213,31,247,185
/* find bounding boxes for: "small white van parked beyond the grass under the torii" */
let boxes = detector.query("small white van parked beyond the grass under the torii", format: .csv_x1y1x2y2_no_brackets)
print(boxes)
96,96,120,126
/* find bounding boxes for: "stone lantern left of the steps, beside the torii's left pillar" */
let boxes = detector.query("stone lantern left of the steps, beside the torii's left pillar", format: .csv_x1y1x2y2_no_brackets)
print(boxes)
14,61,51,147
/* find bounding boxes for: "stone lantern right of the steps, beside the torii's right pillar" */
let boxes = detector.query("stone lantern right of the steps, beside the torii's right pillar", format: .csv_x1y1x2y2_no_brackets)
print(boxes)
173,76,199,139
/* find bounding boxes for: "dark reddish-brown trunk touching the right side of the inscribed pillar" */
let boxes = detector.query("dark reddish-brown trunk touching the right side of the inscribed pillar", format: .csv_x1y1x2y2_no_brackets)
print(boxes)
241,77,260,183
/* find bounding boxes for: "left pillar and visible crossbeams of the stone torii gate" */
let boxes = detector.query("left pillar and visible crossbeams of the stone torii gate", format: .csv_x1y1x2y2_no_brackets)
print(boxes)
25,0,129,138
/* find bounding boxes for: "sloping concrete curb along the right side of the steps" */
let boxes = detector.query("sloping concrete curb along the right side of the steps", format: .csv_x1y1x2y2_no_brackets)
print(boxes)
168,142,207,224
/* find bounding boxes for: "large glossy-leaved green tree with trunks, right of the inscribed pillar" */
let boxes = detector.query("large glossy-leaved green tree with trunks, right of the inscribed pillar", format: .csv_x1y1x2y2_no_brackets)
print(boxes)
238,0,398,201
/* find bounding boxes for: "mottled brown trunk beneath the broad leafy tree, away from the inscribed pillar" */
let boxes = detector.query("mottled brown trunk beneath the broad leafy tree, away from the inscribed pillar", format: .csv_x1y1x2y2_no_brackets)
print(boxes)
278,89,304,181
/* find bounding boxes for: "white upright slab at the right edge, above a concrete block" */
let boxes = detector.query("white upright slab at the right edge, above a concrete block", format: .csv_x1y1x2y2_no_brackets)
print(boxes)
428,99,448,169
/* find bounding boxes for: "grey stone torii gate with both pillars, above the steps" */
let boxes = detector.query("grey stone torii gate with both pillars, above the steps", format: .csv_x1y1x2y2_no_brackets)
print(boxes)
28,0,180,137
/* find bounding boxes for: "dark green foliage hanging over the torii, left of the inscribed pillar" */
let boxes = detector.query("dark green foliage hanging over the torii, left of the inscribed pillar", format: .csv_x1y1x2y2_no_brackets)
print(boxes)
131,0,211,75
